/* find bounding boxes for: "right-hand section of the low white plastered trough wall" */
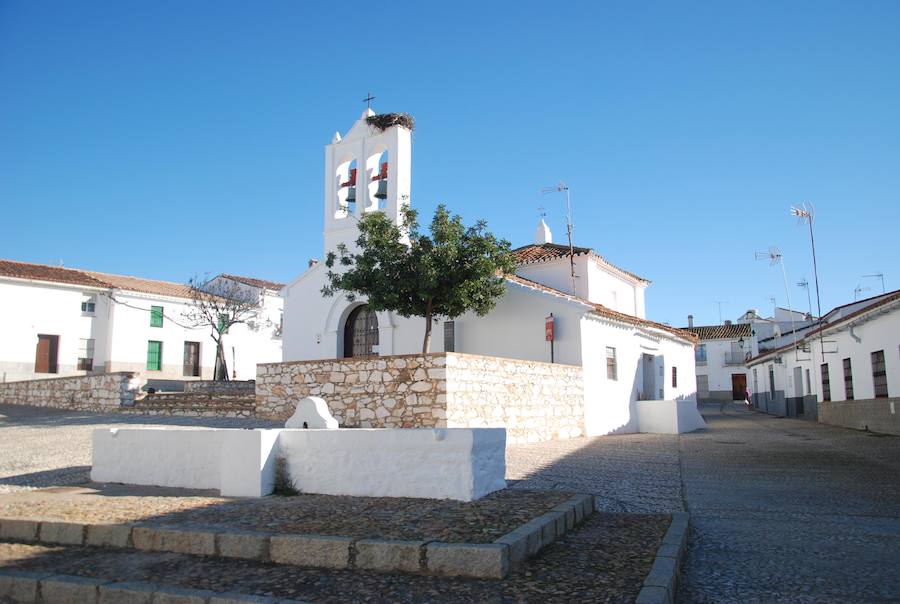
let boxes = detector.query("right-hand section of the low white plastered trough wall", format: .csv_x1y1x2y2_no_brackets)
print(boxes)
279,428,506,501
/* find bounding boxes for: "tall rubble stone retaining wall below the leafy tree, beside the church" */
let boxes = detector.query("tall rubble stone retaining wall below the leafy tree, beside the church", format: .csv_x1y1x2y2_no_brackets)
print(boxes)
256,353,584,443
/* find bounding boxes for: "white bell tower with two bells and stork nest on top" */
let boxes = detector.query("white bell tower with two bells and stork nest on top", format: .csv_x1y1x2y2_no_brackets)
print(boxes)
324,109,412,256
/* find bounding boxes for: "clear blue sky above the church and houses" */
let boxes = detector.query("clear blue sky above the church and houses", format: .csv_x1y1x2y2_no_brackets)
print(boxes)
0,0,900,325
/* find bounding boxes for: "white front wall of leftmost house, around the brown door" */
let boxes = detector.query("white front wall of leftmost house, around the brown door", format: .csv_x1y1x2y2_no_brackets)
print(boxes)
0,280,111,381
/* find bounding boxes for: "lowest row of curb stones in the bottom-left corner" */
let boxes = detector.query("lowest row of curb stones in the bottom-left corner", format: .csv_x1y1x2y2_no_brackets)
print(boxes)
0,568,307,604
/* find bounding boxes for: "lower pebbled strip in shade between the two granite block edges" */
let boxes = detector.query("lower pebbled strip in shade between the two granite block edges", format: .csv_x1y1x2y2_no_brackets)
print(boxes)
0,514,669,604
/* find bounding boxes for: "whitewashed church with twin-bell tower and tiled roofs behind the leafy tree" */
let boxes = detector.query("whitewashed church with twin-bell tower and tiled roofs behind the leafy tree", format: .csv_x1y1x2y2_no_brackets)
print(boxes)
282,109,699,435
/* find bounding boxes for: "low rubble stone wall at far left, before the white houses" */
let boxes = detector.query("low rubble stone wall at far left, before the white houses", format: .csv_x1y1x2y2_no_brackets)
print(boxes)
0,371,140,411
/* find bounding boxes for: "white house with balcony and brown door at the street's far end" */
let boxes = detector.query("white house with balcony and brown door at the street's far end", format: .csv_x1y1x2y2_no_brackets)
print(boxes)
683,315,755,403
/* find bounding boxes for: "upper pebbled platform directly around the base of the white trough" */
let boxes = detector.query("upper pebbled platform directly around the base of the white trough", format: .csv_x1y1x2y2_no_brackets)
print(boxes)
0,485,572,543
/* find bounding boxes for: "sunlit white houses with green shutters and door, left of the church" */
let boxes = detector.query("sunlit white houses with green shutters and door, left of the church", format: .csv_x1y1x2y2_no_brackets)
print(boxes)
0,260,282,381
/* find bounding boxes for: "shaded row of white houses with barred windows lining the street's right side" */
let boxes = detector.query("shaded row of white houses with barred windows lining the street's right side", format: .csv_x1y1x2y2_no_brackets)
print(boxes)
748,291,900,434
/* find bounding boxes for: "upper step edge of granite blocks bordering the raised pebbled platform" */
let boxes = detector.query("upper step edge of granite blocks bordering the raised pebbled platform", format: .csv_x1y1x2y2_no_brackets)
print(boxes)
0,495,594,579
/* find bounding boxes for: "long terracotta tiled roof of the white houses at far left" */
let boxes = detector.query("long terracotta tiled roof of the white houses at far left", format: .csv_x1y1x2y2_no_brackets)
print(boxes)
0,260,190,298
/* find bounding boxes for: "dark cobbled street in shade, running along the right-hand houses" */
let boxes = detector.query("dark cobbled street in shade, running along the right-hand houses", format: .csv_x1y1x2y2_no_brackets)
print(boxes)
679,406,900,603
